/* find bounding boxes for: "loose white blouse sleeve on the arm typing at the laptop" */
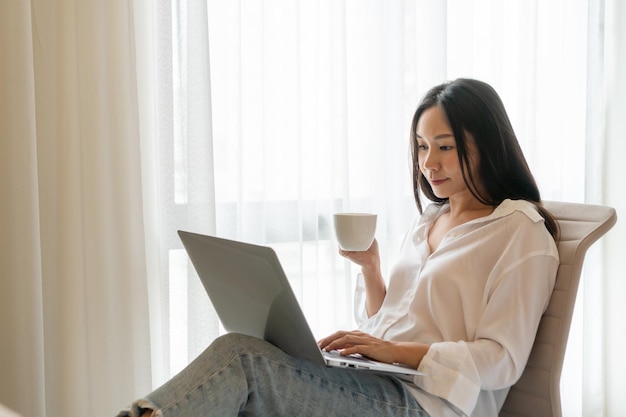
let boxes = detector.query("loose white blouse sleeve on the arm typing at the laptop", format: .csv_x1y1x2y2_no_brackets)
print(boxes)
414,253,558,415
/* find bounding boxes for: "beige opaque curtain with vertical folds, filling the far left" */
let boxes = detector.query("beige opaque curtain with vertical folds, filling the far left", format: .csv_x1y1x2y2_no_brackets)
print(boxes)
0,0,150,417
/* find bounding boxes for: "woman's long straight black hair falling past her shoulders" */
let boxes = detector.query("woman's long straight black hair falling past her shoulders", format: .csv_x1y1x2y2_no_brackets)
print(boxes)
411,78,558,239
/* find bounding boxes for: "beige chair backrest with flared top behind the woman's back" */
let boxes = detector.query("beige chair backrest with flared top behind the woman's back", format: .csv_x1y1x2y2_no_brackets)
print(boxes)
500,201,617,417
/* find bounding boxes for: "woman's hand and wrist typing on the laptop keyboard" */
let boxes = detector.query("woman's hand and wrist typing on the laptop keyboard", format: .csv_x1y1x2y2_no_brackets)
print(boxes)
318,330,428,369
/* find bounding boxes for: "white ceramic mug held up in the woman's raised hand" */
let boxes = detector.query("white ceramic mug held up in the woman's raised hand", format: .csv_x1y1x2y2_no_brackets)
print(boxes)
334,213,377,252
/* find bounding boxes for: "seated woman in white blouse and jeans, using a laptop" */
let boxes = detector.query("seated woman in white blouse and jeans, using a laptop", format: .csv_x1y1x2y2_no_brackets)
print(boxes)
120,79,559,417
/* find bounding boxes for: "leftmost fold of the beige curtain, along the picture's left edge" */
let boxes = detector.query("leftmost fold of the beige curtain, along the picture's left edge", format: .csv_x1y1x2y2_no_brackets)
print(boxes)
0,2,45,416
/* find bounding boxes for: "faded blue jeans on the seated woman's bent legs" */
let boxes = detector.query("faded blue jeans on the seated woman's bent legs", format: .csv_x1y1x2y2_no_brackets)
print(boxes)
118,334,428,417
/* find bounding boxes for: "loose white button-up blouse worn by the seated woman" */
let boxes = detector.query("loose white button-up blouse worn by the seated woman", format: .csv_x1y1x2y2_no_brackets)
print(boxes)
355,200,559,417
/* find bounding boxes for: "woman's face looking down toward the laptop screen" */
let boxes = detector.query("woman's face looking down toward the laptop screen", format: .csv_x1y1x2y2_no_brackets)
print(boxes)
415,106,475,199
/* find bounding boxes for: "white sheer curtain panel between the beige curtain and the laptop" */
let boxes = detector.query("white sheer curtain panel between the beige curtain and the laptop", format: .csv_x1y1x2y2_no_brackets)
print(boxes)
133,0,219,385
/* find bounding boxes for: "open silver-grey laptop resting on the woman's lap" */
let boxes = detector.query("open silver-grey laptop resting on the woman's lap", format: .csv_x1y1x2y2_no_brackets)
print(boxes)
178,230,424,377
